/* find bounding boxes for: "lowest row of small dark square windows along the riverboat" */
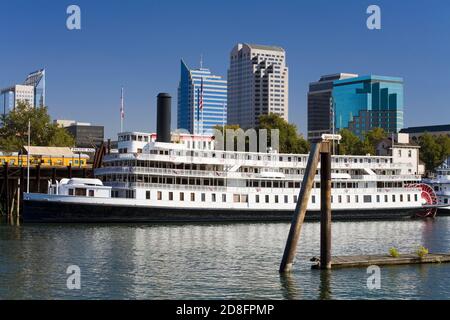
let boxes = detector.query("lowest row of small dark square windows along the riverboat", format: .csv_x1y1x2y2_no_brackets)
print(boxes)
135,190,418,203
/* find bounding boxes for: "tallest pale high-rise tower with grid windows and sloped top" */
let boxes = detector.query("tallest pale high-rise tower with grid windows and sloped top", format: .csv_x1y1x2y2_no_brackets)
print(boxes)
228,43,289,129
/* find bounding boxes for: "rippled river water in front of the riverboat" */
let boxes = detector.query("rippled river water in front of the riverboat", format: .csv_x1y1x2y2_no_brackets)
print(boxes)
0,217,450,299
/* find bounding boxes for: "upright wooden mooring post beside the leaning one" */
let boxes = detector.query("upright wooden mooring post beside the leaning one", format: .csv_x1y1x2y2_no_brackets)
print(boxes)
320,141,331,269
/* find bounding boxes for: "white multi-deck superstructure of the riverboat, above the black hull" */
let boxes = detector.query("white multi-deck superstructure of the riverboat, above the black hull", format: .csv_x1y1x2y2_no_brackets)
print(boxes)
90,132,424,211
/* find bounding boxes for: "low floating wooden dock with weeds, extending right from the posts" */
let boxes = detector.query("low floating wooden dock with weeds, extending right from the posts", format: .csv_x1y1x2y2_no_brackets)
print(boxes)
312,253,450,269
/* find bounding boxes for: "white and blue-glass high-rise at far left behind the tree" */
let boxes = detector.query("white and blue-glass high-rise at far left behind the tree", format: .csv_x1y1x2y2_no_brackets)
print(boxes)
0,69,45,114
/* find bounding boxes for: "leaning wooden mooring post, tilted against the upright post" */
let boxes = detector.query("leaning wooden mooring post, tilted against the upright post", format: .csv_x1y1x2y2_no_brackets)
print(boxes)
279,142,321,273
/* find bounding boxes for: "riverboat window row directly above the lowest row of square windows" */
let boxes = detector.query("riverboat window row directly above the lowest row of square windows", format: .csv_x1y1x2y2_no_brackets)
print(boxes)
99,174,410,189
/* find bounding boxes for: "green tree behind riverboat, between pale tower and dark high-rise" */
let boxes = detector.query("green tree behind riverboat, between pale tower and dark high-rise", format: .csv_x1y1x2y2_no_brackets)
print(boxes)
258,113,310,153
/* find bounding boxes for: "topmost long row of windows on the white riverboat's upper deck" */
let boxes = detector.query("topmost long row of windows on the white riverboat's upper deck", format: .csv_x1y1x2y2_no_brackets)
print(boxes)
146,149,393,163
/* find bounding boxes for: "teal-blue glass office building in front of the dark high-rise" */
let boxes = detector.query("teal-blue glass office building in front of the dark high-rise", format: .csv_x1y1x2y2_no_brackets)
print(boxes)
332,75,403,137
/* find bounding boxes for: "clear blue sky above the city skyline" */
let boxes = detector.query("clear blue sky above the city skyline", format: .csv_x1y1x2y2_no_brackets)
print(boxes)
0,0,450,138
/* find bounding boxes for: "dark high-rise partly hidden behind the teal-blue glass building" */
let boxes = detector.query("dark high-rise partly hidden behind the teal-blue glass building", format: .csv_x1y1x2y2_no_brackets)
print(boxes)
308,73,358,140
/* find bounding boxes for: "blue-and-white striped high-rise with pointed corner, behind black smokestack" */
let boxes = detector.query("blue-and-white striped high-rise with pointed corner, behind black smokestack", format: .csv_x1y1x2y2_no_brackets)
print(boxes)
177,60,227,134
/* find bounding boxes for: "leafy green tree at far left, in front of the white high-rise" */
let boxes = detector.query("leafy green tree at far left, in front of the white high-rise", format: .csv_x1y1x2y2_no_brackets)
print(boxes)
0,102,75,152
